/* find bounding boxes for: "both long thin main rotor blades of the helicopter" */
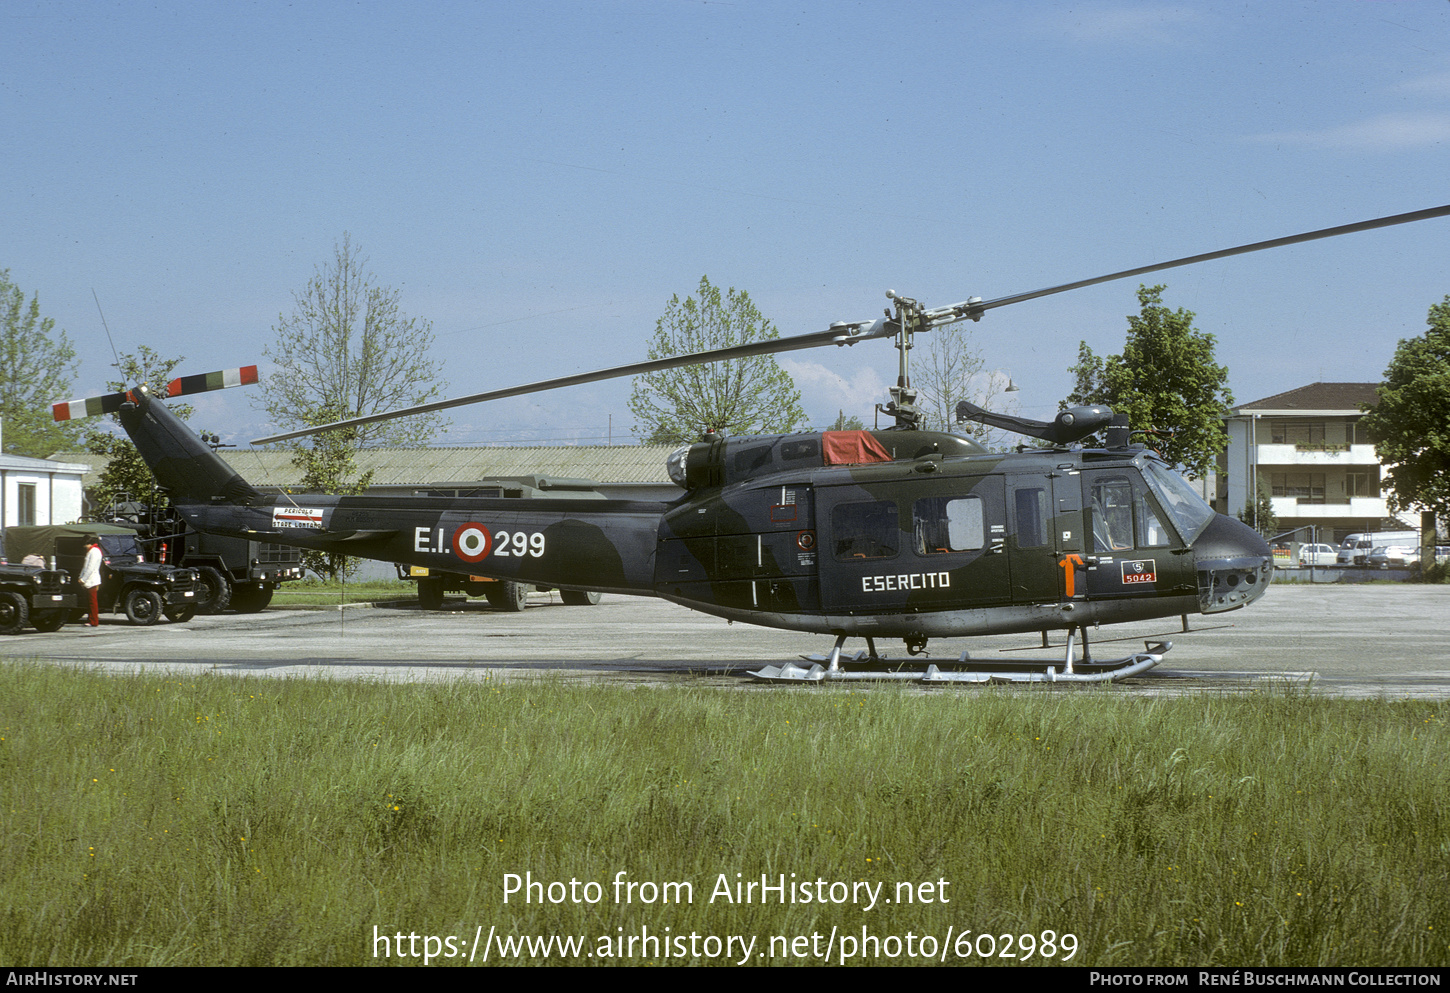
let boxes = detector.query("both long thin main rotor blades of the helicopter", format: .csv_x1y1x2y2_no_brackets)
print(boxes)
252,204,1450,445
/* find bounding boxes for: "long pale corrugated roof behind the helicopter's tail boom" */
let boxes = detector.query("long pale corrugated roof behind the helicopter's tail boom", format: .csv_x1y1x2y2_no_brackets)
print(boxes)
55,445,673,487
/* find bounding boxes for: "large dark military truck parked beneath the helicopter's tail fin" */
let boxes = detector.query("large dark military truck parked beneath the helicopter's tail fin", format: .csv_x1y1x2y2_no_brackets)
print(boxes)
102,503,303,615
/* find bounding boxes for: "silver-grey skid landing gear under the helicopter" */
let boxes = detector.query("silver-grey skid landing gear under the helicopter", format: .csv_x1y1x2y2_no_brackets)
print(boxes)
748,628,1173,686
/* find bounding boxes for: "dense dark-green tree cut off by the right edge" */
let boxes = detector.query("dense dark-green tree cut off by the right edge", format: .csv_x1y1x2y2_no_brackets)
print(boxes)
1360,296,1450,520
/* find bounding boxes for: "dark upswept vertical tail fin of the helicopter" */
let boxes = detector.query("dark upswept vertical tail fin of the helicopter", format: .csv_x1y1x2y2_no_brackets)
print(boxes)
116,387,270,504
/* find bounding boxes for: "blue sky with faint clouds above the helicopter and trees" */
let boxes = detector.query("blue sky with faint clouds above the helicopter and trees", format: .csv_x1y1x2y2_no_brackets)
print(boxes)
0,0,1450,444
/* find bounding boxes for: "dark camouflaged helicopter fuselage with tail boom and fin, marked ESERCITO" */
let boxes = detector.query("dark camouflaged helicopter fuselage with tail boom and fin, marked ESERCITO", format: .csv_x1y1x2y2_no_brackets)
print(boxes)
130,397,1272,639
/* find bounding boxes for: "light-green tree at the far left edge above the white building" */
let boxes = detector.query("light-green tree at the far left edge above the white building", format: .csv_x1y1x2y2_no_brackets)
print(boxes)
0,270,86,458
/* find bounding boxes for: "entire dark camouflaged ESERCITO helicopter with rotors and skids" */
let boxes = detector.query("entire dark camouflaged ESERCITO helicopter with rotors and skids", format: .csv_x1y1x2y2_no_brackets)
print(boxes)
55,204,1450,683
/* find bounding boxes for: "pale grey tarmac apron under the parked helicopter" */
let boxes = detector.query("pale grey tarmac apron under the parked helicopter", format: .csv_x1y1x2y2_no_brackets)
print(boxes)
0,583,1450,700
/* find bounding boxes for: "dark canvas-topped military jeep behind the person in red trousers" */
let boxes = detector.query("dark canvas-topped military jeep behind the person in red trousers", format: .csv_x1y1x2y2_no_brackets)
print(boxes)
4,523,196,626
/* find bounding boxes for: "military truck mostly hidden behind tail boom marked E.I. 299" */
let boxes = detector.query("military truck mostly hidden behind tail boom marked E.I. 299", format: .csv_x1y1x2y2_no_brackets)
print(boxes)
396,475,606,612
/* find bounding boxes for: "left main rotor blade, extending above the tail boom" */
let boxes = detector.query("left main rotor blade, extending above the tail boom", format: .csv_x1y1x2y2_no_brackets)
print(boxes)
252,319,896,445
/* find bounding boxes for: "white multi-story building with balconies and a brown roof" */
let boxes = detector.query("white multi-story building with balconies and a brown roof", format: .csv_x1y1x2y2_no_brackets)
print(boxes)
1218,383,1420,544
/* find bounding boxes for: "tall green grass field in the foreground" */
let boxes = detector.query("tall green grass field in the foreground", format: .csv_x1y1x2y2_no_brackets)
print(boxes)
0,664,1450,965
